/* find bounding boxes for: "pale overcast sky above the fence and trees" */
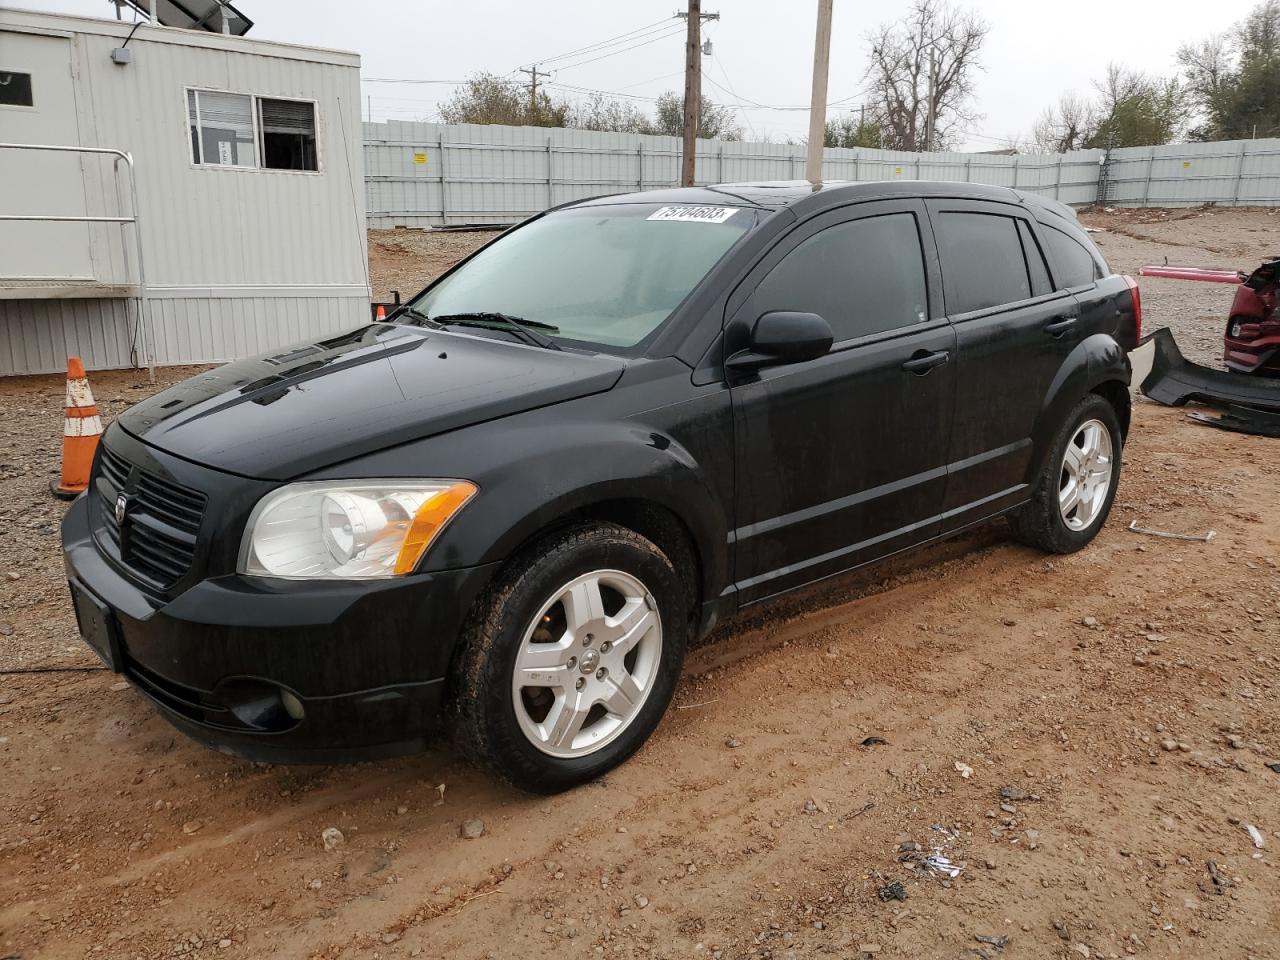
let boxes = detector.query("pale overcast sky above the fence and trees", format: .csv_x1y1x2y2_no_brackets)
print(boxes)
24,0,1256,150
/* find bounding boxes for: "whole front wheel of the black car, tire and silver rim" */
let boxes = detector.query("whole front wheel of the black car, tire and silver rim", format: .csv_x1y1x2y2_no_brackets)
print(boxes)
452,524,689,794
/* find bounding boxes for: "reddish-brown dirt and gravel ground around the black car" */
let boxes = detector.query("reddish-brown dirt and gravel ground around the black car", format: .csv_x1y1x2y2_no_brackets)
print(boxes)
0,212,1280,960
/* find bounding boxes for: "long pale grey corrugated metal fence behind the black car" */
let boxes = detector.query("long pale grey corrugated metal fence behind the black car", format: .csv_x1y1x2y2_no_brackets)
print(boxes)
365,120,1280,228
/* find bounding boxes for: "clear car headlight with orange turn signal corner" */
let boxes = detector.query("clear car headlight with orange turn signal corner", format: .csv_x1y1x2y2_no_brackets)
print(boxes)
238,480,476,580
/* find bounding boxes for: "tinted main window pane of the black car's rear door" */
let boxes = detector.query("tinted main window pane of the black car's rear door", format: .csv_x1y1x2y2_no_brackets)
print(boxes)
936,212,1032,314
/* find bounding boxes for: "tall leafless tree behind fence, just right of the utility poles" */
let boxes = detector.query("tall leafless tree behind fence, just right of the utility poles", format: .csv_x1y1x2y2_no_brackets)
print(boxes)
867,0,991,150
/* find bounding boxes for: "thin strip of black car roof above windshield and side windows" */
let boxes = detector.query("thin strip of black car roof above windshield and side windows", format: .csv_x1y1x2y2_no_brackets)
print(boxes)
564,180,1075,221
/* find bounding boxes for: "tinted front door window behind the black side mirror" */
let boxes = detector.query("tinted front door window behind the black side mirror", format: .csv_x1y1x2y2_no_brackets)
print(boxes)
755,214,928,343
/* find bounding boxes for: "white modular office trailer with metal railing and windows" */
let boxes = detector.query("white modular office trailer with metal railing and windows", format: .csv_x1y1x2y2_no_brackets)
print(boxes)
0,9,369,375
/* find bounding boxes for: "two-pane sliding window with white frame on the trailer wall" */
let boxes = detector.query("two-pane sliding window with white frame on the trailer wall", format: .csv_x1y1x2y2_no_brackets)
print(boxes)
187,90,319,170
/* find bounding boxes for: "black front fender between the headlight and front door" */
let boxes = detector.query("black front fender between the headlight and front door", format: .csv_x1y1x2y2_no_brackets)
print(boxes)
332,407,732,599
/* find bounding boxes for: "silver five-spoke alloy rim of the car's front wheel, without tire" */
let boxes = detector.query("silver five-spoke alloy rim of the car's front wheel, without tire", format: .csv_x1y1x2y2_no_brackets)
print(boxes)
512,570,662,758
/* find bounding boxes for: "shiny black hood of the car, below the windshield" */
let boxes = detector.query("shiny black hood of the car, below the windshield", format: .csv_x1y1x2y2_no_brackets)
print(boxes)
119,324,625,480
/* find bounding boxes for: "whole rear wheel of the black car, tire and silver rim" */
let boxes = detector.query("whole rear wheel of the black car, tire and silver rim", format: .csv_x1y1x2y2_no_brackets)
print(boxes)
1009,393,1123,553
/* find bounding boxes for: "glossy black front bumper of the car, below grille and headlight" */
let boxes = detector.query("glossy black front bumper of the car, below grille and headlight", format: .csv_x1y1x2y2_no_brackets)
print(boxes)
63,497,497,763
